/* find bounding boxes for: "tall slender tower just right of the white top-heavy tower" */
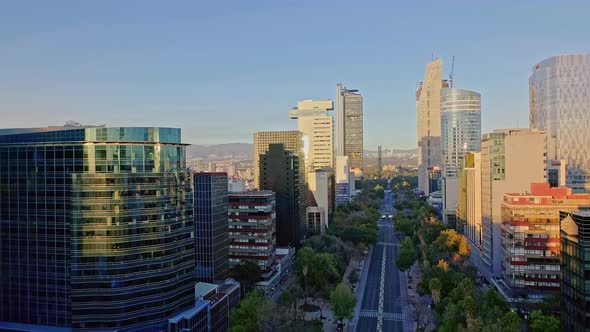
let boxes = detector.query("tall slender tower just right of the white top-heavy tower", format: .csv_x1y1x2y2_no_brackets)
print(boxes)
336,83,363,171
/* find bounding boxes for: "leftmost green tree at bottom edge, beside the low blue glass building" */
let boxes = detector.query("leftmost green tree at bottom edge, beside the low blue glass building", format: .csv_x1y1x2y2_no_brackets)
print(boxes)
229,291,265,332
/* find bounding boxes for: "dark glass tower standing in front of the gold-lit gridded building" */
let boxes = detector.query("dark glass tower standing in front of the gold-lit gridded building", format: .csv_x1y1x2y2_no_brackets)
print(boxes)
260,144,307,248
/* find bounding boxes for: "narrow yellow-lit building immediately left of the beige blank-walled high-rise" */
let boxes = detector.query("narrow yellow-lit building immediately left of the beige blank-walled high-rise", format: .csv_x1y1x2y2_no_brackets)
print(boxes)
457,152,483,250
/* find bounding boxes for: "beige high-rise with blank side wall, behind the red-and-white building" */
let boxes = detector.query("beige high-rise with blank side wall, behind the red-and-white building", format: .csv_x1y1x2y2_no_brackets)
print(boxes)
484,129,546,276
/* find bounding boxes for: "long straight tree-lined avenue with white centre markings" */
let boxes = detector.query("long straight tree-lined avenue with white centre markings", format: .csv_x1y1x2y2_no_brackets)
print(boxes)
356,184,404,332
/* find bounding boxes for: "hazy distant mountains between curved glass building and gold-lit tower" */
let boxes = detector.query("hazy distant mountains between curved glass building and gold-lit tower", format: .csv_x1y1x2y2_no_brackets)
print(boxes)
186,143,254,160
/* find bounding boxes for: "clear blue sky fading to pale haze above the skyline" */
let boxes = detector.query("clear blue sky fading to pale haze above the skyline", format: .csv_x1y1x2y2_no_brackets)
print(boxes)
0,0,590,149
